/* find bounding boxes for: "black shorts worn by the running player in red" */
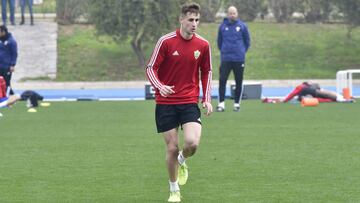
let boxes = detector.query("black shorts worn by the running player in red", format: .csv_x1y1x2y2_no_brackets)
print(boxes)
155,104,201,133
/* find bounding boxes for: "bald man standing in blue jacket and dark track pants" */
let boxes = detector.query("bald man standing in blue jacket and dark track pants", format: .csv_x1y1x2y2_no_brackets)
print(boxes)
216,6,250,112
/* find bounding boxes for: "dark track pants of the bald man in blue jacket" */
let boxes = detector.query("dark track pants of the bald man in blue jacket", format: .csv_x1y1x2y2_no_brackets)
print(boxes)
219,61,245,103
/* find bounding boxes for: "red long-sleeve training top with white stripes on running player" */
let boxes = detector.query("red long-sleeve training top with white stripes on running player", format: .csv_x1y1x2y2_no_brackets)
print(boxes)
146,30,212,104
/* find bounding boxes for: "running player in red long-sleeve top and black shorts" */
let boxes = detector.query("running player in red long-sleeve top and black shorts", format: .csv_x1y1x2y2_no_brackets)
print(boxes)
146,3,212,202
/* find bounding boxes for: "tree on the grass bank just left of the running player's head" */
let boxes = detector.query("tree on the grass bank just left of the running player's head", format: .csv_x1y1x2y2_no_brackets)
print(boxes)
90,0,178,67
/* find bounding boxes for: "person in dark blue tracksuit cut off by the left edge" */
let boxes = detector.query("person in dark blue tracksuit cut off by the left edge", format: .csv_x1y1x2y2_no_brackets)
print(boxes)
0,25,18,95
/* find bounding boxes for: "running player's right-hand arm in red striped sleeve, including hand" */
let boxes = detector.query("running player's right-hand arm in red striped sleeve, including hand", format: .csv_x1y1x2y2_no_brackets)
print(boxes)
200,45,212,115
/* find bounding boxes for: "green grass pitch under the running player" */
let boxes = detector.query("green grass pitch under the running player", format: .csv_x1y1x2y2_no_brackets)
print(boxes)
0,100,360,203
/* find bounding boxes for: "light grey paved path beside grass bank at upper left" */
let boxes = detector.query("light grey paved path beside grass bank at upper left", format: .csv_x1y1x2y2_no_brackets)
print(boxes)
8,19,57,82
